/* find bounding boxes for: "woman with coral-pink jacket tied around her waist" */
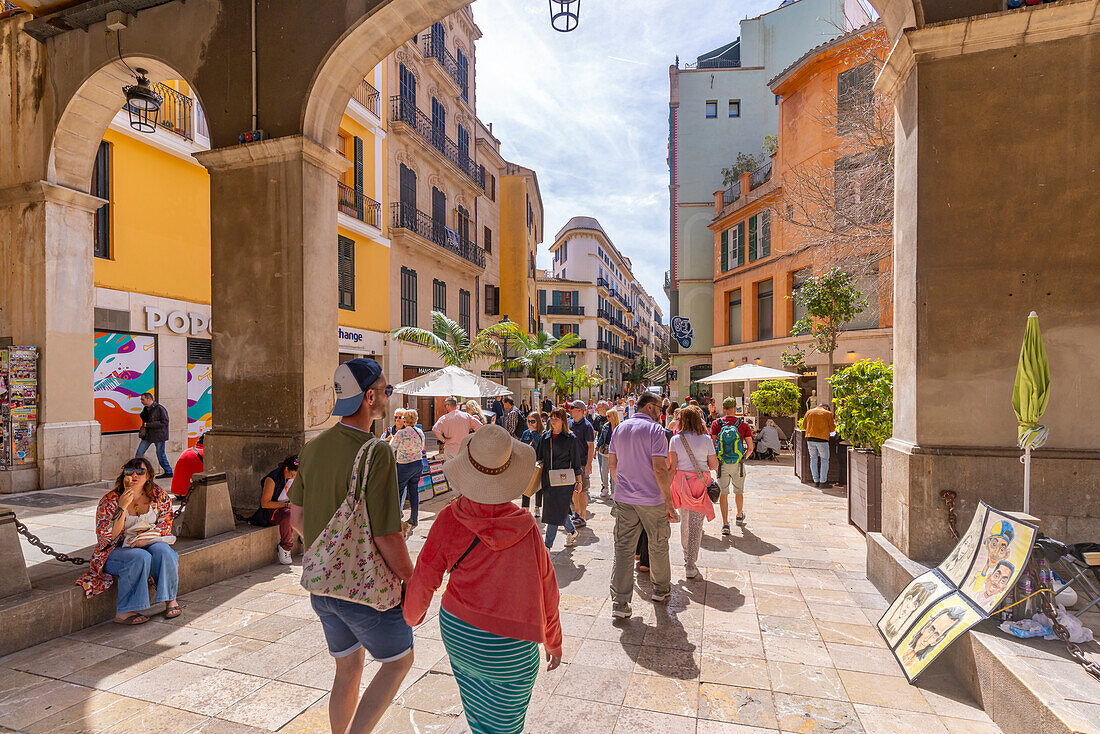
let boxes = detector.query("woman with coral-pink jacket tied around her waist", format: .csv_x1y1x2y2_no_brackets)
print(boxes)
669,406,718,579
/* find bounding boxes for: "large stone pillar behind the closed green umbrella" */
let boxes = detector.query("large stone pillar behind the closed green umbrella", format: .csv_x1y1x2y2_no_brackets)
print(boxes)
877,3,1100,563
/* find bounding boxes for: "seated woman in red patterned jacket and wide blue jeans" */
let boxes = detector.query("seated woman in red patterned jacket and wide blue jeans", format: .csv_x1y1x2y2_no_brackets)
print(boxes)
76,458,183,625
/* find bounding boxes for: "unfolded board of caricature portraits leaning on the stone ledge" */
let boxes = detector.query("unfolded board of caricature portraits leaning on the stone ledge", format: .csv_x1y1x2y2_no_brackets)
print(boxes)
878,502,1036,682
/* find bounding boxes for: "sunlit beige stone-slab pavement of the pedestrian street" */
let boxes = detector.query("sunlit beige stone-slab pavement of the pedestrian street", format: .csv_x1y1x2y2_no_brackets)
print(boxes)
0,463,1000,734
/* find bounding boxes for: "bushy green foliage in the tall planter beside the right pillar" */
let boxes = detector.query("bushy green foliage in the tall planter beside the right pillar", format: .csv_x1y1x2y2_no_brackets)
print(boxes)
829,360,893,453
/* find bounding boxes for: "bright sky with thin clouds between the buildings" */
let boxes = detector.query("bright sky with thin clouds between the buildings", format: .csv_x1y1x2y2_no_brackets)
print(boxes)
472,0,779,316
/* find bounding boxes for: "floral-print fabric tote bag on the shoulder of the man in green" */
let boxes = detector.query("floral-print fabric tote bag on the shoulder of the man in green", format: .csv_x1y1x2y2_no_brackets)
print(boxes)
301,437,402,612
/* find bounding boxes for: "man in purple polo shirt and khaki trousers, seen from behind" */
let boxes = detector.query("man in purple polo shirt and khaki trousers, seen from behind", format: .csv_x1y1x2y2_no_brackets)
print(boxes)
609,392,678,618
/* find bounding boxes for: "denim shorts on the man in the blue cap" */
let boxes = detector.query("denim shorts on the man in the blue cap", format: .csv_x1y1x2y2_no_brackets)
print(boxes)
309,594,413,662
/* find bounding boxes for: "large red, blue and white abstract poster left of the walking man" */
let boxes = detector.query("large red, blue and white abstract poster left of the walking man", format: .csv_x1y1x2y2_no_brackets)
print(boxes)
92,331,156,434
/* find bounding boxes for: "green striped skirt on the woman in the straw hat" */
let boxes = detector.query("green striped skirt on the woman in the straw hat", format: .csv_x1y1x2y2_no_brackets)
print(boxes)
439,610,539,734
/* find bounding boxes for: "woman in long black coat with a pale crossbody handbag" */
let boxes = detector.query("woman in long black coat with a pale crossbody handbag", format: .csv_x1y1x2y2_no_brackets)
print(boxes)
538,408,583,548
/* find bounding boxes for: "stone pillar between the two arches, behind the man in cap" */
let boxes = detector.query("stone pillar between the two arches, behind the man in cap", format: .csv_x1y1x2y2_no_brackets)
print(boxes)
196,135,347,510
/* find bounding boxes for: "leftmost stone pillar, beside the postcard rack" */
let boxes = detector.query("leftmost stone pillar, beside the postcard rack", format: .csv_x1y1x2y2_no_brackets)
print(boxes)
0,180,103,489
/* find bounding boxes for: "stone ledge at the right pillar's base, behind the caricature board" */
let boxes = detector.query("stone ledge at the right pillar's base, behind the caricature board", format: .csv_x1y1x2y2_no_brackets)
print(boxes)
867,533,1100,734
